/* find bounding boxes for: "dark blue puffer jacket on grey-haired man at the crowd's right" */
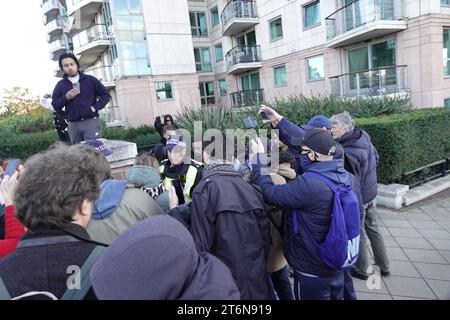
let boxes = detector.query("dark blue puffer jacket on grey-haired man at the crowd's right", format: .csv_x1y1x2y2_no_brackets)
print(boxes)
339,128,380,203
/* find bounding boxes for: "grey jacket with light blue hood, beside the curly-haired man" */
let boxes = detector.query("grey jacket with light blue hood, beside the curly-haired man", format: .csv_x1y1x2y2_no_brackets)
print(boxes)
87,180,164,244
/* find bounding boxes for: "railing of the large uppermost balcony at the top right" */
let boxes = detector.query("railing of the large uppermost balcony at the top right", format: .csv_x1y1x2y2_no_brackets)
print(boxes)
325,0,404,41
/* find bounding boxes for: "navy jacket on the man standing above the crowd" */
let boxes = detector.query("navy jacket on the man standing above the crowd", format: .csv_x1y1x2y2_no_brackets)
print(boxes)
52,72,111,121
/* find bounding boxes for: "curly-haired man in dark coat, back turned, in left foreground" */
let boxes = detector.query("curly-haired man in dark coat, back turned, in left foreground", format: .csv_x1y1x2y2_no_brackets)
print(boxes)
0,145,104,299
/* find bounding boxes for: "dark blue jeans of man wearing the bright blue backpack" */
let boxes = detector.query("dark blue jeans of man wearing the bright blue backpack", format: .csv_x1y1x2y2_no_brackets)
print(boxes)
294,270,344,300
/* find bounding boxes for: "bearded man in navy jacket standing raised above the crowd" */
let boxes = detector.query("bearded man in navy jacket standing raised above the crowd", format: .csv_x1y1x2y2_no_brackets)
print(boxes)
52,53,111,144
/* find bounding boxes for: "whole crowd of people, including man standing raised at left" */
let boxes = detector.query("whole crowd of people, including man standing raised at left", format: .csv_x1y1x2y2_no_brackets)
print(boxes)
0,54,389,300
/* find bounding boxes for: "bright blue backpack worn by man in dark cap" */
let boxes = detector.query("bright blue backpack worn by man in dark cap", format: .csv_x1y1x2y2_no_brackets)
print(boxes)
294,172,361,270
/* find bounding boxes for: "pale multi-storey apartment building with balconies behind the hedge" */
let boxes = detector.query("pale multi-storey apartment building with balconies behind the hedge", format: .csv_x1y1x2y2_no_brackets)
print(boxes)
41,0,450,126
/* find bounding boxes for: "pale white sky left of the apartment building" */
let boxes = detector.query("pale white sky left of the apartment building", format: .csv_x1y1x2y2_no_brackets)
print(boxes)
0,0,58,98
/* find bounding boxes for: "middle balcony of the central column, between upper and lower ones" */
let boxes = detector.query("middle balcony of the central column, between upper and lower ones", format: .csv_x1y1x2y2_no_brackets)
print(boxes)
225,46,262,74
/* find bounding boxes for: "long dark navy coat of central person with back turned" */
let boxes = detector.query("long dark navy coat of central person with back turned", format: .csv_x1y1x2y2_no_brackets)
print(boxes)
191,171,272,300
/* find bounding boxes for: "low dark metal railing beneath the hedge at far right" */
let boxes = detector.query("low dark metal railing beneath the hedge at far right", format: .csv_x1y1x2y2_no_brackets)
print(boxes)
399,158,450,188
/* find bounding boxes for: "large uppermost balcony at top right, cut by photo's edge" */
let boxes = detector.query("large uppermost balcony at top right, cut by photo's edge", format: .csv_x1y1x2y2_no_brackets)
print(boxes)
325,0,406,48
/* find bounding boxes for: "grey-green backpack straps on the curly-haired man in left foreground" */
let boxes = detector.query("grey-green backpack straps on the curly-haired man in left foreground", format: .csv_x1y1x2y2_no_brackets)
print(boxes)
0,246,106,300
